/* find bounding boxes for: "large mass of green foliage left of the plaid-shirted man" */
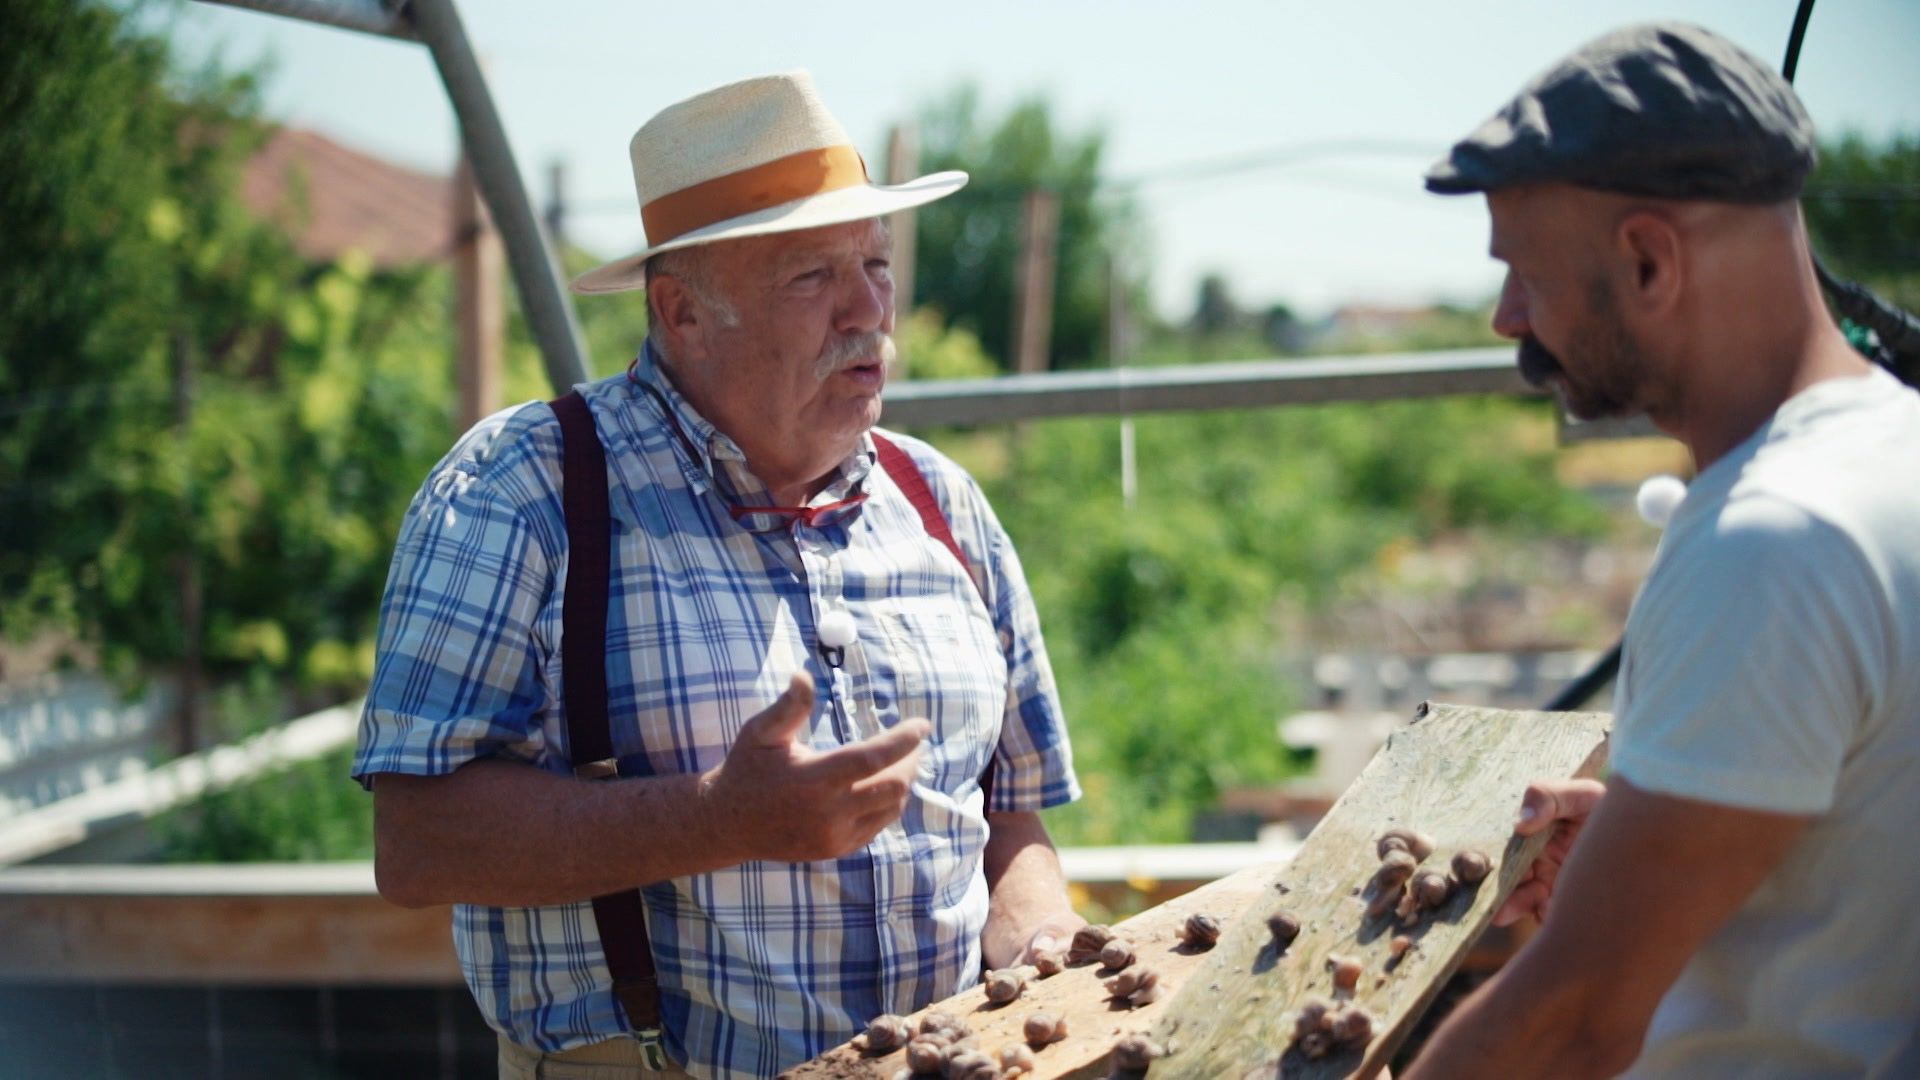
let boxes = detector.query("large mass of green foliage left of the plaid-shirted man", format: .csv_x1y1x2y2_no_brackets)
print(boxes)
0,0,464,696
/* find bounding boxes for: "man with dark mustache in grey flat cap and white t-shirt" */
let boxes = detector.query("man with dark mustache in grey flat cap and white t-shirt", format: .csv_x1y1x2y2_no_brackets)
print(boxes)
1411,25,1920,1078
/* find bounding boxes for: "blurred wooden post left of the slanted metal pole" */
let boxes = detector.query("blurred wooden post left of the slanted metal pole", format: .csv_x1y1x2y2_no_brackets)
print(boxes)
453,154,507,430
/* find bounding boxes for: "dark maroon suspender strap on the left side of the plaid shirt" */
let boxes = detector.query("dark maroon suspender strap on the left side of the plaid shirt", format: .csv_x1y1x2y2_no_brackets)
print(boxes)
549,394,660,1047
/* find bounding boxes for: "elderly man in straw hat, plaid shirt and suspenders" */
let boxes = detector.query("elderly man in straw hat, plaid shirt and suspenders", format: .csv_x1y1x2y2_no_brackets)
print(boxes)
353,73,1081,1076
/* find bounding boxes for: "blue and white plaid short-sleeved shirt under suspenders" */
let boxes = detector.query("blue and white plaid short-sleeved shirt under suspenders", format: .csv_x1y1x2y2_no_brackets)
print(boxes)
353,354,1079,1076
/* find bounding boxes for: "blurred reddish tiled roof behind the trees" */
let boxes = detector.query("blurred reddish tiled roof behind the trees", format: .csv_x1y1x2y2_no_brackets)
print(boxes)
242,127,453,267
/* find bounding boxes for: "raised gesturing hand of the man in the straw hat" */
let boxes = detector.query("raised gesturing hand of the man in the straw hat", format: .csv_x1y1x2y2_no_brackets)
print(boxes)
701,673,933,863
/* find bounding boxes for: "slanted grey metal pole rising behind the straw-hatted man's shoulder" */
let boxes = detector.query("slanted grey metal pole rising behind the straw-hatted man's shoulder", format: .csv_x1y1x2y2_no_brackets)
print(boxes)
407,0,588,394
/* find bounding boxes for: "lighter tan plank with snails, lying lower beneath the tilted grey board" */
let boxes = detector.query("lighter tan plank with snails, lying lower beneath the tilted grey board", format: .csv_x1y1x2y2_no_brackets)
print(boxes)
783,853,1279,1080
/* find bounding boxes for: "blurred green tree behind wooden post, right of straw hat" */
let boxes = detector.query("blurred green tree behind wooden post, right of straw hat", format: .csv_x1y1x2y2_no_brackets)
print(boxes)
914,86,1137,367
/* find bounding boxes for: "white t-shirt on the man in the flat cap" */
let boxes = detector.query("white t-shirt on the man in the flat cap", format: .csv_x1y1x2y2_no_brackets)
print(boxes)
1613,369,1920,1078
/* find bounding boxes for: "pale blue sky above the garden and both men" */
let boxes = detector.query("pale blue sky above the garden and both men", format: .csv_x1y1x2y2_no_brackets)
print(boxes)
163,0,1920,315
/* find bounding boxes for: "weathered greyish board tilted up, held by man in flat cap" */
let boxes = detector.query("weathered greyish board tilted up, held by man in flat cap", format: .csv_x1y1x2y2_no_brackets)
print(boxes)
1150,705,1611,1080
